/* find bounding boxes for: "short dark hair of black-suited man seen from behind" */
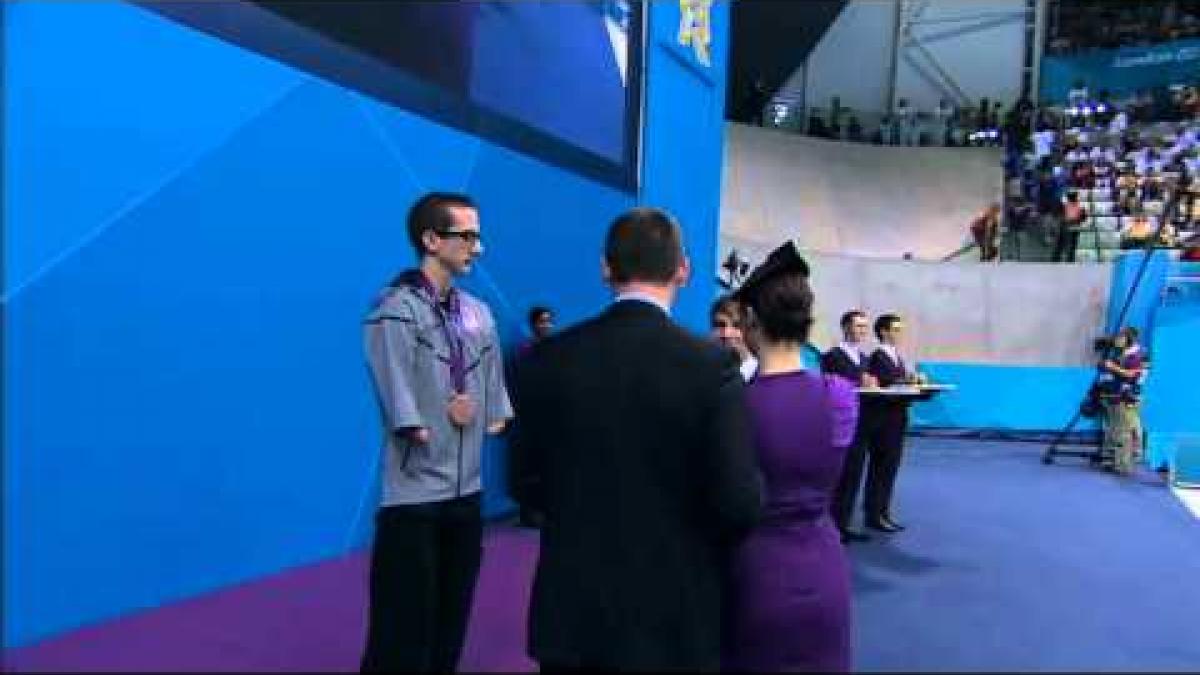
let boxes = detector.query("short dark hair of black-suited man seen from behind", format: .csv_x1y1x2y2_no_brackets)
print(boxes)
604,207,683,283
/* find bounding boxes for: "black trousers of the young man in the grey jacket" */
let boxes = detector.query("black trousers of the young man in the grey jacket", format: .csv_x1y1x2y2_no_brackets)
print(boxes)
361,494,484,673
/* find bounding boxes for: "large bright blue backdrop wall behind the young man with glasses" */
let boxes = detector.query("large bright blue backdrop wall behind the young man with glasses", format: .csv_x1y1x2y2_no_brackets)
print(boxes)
2,1,728,646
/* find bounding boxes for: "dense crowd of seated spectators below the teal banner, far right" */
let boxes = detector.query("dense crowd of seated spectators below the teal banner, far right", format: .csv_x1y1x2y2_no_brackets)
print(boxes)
1006,86,1200,262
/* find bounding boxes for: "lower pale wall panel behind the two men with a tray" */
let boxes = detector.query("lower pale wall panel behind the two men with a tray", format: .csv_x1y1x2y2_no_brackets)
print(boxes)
722,246,1111,366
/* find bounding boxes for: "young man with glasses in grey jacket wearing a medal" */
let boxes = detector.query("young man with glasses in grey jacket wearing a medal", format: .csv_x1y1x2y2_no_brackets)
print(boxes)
361,192,512,673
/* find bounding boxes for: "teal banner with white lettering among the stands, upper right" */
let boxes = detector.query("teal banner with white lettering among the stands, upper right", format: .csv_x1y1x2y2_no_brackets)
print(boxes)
1038,40,1200,103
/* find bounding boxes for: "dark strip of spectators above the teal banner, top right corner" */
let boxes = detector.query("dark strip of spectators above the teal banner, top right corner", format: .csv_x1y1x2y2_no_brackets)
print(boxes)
1046,0,1200,55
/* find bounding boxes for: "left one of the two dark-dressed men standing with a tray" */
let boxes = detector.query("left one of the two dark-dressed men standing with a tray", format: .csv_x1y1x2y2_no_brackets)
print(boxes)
821,310,878,543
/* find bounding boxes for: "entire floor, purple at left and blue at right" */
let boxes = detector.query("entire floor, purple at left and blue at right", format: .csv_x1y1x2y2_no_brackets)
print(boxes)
4,438,1200,671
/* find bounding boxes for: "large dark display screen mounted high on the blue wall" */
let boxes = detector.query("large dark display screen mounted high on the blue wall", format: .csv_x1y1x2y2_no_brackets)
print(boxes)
142,0,644,190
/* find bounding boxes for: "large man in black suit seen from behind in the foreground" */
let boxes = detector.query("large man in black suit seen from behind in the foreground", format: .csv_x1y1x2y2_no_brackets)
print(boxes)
515,208,762,670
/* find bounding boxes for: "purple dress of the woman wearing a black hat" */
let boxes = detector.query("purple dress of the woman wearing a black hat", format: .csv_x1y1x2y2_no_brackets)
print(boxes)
725,371,858,673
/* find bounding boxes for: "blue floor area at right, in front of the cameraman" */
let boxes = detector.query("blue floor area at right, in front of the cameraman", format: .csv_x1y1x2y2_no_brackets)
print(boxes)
851,438,1200,671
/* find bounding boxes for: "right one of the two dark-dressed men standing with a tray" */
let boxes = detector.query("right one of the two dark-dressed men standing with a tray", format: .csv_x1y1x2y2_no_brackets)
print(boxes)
865,313,917,532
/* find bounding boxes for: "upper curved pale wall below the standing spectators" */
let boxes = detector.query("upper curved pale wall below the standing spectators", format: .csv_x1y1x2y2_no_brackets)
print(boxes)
721,124,1003,259
